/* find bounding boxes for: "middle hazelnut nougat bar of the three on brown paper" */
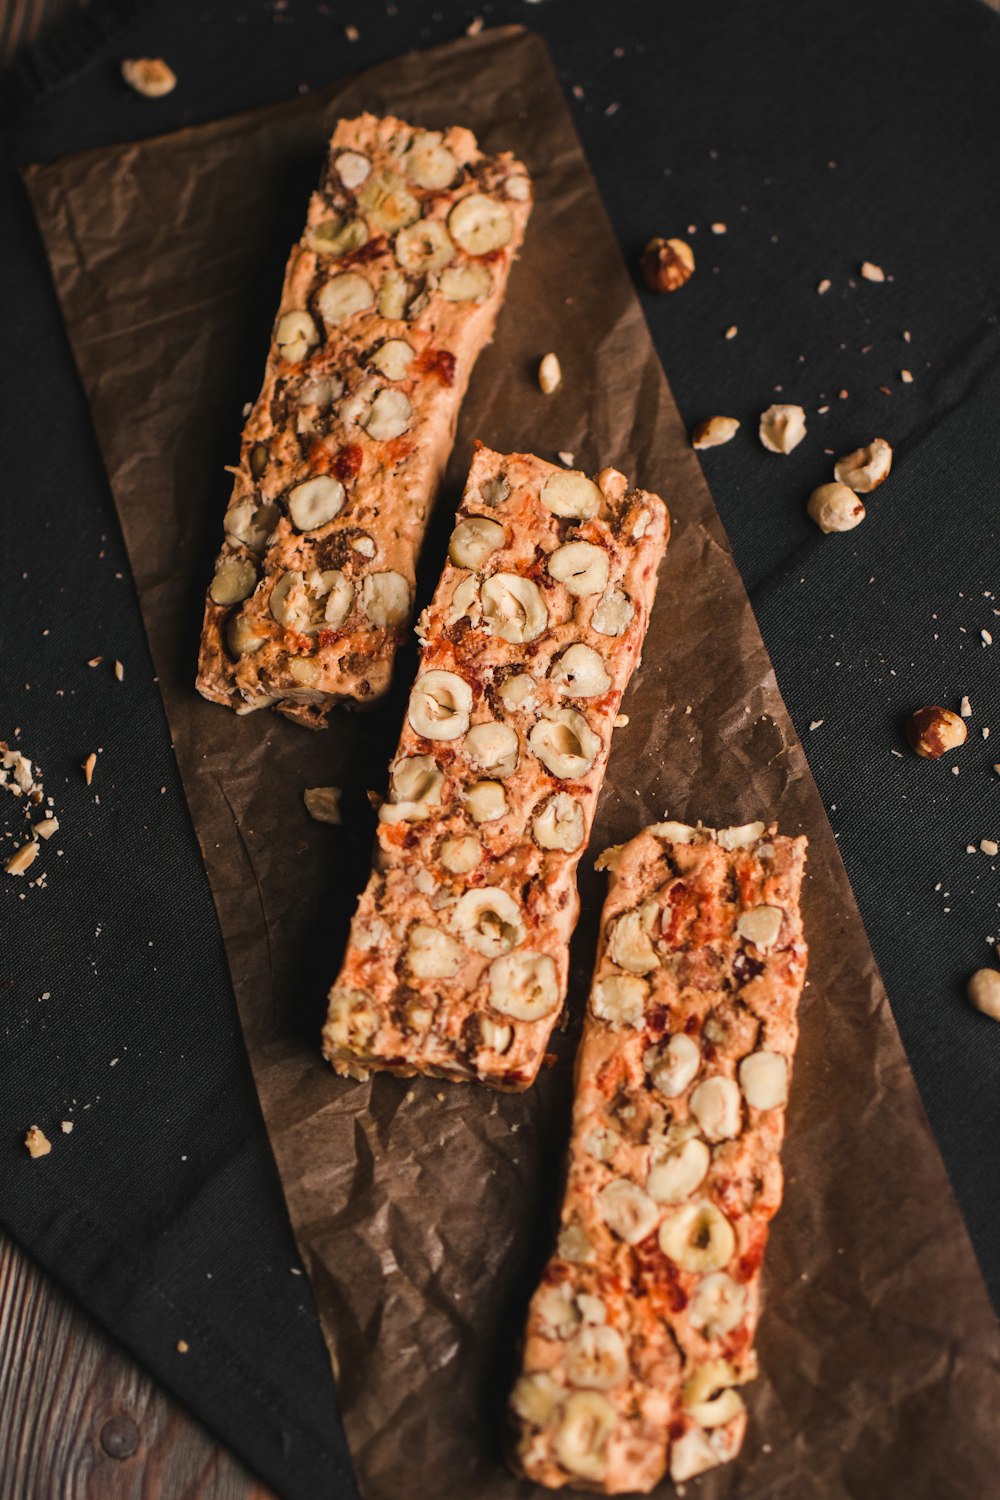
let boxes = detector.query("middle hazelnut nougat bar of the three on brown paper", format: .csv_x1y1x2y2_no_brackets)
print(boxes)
324,446,669,1089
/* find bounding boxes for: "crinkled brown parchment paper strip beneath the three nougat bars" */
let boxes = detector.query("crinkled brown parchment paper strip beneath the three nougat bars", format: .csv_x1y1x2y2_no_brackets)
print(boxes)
27,30,1000,1500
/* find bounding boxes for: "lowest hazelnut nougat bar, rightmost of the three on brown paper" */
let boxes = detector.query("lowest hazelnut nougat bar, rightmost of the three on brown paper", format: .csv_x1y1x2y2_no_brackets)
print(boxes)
511,824,807,1494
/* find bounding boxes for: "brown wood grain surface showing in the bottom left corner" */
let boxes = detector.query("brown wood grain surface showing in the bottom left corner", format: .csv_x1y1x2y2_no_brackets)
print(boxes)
0,1233,274,1500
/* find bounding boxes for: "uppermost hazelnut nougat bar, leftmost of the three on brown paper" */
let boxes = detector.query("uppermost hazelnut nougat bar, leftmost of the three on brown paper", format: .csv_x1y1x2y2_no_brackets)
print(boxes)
198,114,531,728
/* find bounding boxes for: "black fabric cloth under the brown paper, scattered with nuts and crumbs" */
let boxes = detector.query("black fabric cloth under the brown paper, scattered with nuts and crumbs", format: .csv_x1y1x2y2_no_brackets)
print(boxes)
0,0,1000,1500
